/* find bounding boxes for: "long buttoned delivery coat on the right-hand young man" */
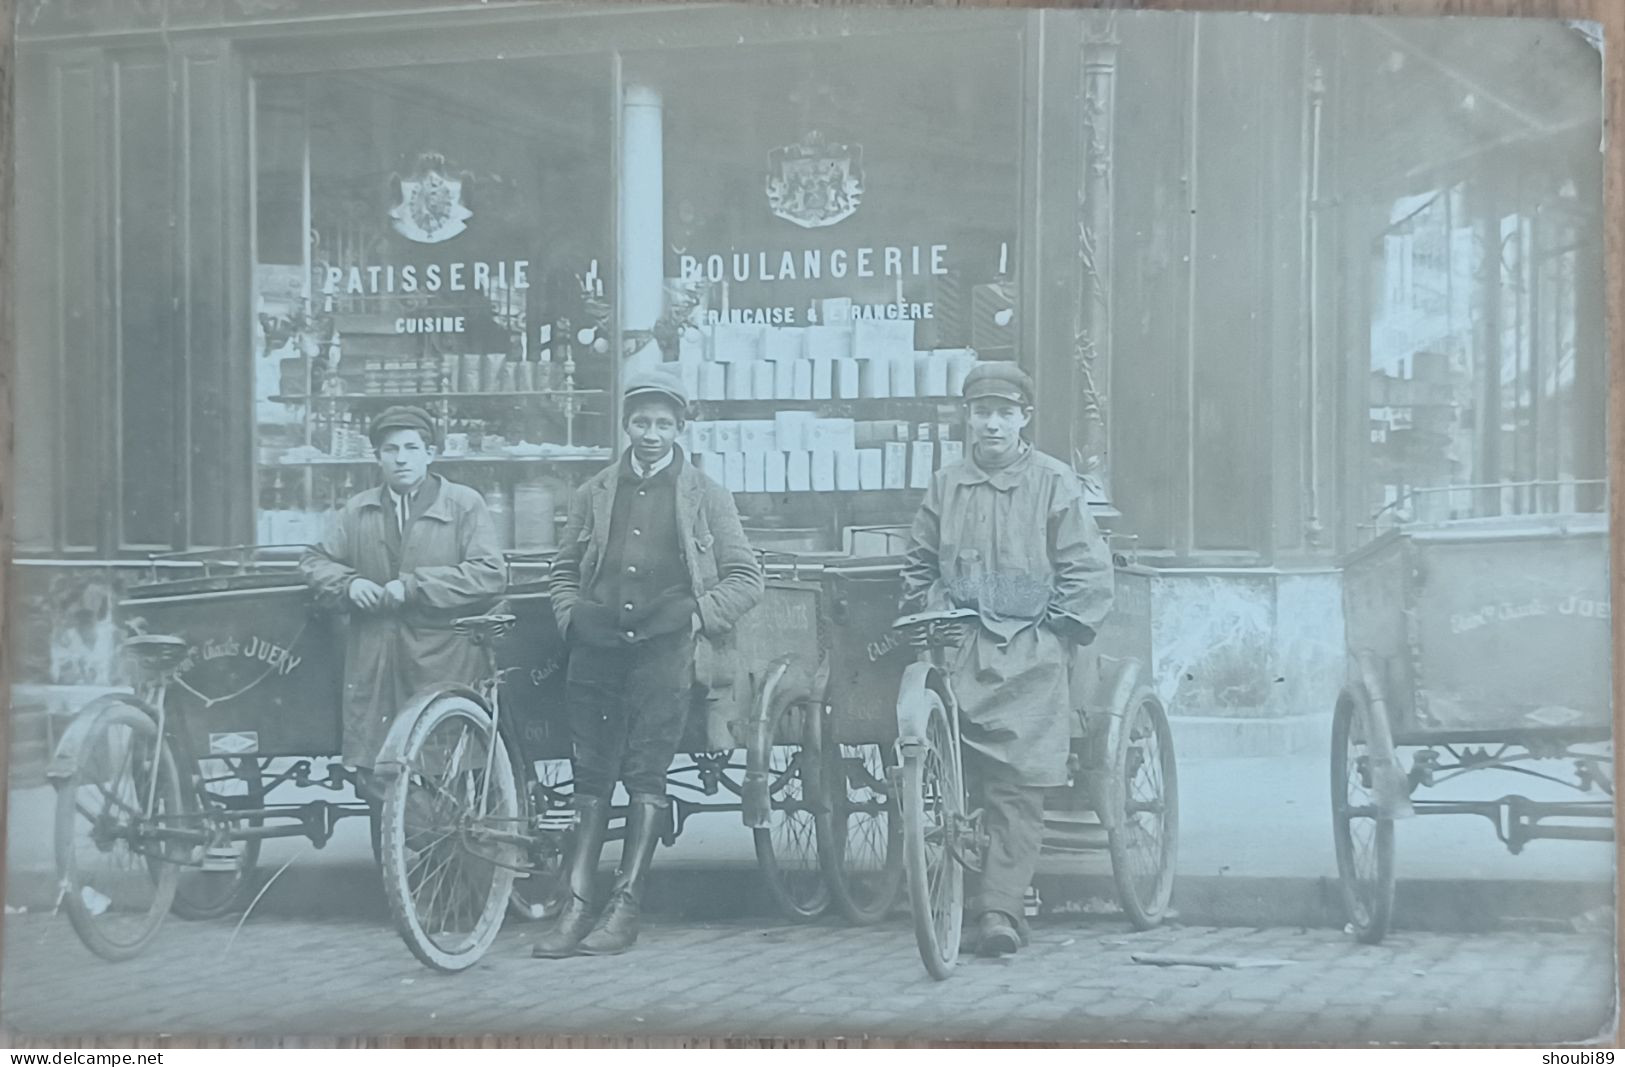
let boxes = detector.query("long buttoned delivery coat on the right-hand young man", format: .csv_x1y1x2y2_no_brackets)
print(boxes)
900,448,1112,786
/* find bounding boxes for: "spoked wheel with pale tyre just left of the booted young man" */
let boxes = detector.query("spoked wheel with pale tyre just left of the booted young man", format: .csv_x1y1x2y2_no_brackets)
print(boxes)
379,693,523,971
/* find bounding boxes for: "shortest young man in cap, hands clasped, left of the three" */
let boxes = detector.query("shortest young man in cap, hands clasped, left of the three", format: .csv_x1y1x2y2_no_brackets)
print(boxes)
299,408,507,796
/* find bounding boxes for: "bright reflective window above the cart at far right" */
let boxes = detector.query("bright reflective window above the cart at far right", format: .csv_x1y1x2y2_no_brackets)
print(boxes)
1363,182,1604,525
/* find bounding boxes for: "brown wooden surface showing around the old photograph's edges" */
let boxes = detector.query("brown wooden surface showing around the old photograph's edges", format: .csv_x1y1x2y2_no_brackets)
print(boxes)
0,0,1625,1049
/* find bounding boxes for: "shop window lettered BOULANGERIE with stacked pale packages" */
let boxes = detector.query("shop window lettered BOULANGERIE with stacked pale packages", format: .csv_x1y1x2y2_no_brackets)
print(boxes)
624,32,1022,552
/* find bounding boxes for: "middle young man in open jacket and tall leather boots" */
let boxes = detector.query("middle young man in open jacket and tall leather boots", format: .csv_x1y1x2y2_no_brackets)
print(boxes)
533,365,762,960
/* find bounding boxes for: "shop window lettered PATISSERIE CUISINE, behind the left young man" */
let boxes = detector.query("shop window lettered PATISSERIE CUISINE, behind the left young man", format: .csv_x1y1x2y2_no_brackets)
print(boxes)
254,57,616,549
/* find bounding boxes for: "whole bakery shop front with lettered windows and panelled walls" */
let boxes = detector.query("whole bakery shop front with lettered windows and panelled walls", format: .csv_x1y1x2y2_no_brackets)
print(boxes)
13,0,1604,760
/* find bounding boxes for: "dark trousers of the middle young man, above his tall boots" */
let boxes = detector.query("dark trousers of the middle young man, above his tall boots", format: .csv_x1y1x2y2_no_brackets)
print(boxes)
566,632,694,799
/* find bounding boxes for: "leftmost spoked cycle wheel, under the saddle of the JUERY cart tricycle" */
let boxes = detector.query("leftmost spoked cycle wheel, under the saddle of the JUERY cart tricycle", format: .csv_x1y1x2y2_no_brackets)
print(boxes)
55,703,185,960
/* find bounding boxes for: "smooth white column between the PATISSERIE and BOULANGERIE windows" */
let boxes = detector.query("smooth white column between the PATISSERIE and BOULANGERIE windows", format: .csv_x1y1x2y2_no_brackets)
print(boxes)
618,84,666,384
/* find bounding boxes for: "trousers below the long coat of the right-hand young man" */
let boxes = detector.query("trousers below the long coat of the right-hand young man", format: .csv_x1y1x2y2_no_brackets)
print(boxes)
965,749,1045,922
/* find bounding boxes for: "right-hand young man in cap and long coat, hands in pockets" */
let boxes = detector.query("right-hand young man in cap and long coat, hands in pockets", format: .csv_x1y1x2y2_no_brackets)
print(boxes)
900,361,1112,955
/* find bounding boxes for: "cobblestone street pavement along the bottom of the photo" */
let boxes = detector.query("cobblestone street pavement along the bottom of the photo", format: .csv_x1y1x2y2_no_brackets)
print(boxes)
0,914,1614,1044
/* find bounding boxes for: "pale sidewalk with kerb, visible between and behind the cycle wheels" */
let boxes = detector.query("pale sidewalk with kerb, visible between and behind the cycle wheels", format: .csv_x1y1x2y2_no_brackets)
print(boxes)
7,743,1614,931
